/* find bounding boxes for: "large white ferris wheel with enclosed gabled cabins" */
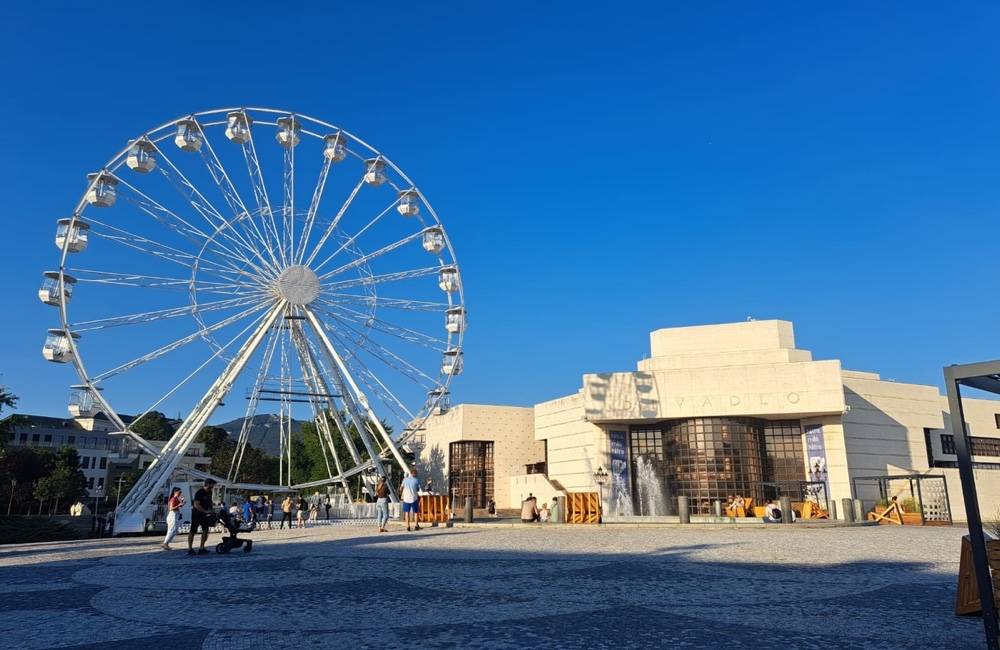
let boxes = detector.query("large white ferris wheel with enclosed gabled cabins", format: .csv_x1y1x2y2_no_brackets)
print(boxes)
39,108,466,531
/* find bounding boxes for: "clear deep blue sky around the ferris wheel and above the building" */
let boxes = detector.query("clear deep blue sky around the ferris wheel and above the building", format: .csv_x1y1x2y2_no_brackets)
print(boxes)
0,2,1000,415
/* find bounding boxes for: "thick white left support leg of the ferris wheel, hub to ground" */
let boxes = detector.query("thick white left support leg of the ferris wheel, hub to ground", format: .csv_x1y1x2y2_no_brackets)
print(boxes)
115,300,286,533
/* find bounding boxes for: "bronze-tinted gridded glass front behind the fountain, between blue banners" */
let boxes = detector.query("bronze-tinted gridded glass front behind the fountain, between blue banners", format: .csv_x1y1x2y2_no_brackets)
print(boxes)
629,418,805,515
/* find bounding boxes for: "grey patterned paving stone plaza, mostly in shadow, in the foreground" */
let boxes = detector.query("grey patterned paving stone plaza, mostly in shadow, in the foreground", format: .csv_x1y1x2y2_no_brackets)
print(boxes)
0,525,983,650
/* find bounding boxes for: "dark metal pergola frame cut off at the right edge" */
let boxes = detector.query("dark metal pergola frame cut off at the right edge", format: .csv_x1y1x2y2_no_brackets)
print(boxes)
944,360,1000,648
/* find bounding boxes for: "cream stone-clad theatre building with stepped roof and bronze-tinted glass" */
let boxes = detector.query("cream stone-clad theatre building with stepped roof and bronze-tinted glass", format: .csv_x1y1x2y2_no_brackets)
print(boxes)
420,320,1000,521
